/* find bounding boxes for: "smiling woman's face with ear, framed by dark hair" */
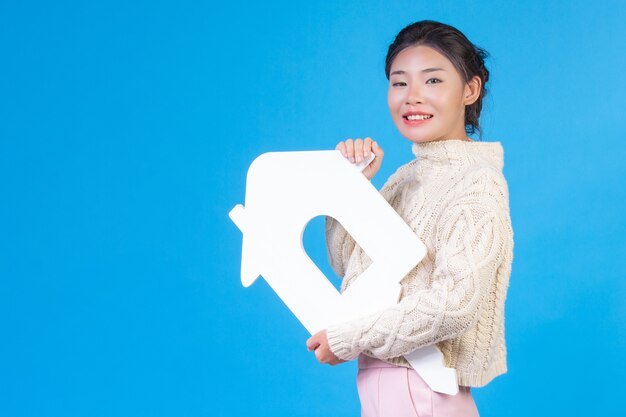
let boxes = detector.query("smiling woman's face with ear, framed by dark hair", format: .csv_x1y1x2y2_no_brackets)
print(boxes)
387,45,472,142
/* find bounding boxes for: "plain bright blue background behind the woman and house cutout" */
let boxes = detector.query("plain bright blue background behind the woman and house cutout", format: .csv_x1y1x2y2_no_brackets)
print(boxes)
0,0,626,417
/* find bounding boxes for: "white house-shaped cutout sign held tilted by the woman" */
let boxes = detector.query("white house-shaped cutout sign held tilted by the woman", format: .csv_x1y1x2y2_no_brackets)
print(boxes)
229,150,458,394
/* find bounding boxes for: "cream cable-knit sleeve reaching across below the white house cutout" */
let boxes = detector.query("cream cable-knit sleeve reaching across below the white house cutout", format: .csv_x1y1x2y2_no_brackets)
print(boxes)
327,196,506,360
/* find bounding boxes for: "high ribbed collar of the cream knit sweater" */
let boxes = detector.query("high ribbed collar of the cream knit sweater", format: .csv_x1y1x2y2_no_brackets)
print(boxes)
412,139,504,171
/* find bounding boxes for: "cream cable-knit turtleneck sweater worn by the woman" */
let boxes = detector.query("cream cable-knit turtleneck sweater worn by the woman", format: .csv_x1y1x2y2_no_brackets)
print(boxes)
326,139,513,387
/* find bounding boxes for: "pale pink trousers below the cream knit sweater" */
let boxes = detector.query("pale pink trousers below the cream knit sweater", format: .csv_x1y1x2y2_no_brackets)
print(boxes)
356,354,478,417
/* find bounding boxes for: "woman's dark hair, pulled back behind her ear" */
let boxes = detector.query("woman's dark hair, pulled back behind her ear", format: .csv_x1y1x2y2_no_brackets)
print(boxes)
385,20,489,136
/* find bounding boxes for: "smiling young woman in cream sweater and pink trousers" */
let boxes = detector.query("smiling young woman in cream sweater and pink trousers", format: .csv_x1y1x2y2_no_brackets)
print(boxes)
307,21,513,417
